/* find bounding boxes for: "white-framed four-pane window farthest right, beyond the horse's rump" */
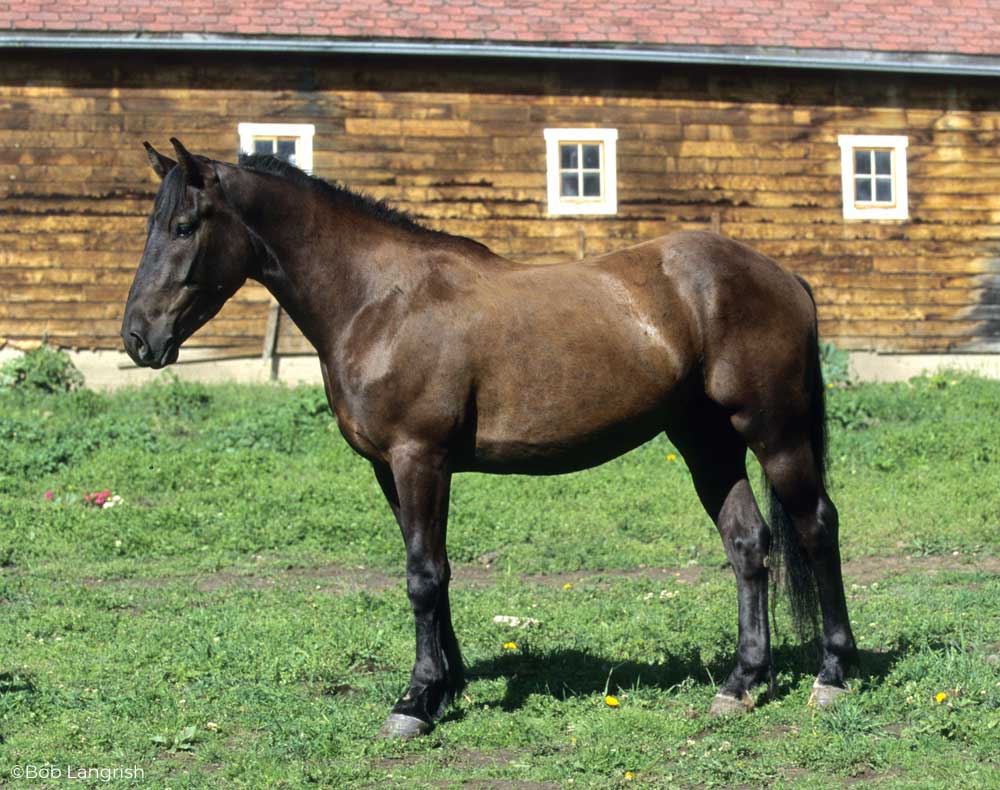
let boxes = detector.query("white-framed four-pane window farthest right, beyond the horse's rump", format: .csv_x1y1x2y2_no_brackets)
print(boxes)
837,134,909,219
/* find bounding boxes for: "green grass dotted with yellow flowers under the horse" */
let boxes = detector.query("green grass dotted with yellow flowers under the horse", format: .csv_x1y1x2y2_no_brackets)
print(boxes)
0,376,1000,788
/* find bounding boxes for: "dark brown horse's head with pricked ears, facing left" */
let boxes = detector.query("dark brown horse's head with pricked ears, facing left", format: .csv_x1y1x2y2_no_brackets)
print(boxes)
122,139,253,368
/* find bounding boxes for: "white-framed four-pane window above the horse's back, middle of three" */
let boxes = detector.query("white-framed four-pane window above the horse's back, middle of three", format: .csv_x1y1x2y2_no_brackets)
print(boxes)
545,129,618,214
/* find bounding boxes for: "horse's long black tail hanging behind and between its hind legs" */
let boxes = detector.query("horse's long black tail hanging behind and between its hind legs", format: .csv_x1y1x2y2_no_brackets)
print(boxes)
764,275,827,642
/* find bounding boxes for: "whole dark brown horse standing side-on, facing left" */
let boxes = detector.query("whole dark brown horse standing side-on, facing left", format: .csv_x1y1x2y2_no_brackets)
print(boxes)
122,140,856,737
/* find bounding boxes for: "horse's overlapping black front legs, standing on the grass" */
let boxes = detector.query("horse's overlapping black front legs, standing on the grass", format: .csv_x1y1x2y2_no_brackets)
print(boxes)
375,445,464,738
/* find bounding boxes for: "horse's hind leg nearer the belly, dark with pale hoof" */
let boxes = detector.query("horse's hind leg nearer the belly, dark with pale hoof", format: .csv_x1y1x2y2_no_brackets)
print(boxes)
667,403,772,715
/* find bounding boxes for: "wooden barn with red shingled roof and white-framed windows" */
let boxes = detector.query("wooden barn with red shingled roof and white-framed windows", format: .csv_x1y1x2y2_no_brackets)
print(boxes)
0,0,1000,383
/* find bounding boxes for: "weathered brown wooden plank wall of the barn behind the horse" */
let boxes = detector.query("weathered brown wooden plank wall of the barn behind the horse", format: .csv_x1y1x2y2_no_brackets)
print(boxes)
0,52,1000,354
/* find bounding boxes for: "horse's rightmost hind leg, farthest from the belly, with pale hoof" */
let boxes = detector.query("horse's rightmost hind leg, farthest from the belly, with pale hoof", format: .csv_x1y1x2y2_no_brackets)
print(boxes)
758,446,857,705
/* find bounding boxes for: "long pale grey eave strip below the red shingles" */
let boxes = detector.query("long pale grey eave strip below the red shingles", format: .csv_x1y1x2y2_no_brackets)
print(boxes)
0,32,1000,77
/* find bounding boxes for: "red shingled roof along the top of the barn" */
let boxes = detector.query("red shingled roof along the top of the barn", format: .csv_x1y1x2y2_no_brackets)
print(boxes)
0,0,1000,55
